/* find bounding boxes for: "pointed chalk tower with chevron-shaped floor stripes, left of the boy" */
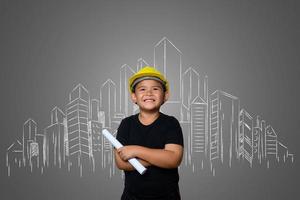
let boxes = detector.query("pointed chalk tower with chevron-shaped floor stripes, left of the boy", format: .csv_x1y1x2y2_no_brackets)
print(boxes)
66,84,91,175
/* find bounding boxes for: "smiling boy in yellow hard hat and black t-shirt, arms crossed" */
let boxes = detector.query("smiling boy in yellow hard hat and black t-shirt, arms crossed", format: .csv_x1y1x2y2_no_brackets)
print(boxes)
115,67,183,200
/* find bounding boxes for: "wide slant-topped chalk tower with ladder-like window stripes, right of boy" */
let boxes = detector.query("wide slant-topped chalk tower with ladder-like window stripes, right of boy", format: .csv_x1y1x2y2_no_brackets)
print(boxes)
210,90,240,167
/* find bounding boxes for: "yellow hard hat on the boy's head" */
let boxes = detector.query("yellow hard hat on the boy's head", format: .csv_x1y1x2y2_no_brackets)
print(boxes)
129,66,169,92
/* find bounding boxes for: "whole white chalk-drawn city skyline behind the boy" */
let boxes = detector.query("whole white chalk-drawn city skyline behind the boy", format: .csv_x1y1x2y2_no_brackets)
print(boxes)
6,37,294,177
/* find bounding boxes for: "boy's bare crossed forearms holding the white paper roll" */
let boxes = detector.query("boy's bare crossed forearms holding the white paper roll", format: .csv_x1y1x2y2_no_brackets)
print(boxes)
115,144,183,171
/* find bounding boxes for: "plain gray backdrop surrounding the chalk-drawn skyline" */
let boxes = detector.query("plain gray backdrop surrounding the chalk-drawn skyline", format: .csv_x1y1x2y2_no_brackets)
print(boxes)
0,0,300,200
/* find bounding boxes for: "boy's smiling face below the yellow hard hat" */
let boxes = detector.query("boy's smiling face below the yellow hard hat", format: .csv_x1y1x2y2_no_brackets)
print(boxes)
131,80,169,111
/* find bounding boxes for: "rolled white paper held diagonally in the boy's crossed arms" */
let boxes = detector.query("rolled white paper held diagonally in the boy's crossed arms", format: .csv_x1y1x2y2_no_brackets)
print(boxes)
102,129,147,175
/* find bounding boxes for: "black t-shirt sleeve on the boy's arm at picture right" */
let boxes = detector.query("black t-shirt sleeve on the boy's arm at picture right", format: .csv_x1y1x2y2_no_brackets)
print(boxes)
166,117,183,146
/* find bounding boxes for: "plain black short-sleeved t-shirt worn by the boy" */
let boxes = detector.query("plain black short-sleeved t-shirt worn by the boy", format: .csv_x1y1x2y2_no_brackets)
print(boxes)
117,113,183,199
